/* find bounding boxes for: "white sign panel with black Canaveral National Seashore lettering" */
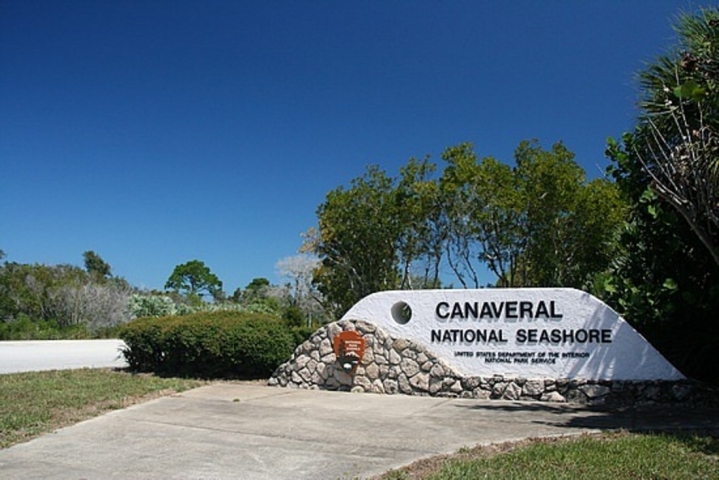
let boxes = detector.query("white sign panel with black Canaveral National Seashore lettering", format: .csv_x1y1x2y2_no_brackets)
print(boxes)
342,288,684,380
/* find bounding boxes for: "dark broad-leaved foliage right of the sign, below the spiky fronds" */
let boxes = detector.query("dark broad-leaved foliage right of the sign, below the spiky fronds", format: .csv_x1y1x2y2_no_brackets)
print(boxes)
608,134,719,381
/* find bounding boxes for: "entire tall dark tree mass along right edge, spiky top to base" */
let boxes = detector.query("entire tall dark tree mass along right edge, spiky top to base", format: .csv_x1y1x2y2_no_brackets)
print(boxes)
602,8,719,380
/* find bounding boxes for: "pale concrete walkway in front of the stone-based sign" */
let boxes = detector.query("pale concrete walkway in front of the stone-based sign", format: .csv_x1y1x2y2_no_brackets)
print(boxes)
0,384,719,480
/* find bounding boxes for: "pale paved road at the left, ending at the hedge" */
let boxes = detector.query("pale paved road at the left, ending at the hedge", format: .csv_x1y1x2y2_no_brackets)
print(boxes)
0,340,127,374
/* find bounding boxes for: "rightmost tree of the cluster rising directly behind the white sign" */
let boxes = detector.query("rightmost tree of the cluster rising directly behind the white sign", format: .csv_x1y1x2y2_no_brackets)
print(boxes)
514,141,626,288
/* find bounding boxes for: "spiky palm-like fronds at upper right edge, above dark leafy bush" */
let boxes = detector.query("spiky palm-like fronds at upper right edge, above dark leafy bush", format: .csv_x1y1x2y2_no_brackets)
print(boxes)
634,8,719,265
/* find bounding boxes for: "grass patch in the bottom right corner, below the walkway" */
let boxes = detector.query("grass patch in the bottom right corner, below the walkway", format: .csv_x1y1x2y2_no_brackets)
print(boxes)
382,432,719,480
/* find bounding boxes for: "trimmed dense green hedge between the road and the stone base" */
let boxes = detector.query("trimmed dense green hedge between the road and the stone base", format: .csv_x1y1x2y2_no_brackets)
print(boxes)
119,311,295,378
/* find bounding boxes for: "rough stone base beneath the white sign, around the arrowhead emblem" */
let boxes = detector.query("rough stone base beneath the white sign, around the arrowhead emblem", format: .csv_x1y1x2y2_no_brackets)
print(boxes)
269,320,717,407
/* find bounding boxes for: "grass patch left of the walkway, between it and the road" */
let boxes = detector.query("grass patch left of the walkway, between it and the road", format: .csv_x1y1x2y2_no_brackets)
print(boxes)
0,369,203,448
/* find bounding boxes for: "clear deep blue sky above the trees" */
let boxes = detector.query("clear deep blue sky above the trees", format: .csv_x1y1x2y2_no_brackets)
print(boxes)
0,0,709,293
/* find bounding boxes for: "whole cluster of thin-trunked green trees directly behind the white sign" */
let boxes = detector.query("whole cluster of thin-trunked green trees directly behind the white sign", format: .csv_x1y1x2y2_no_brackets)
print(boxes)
312,141,625,316
